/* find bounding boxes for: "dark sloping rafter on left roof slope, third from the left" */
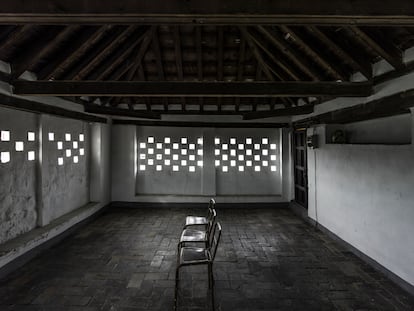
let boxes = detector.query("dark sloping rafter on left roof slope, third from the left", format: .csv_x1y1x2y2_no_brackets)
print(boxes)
73,26,138,80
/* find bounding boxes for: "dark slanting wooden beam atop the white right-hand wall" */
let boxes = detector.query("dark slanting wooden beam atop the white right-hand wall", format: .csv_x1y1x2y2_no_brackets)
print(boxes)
294,89,414,127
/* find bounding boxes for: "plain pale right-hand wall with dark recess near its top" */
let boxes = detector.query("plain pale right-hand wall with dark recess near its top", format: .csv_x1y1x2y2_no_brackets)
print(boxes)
308,115,414,285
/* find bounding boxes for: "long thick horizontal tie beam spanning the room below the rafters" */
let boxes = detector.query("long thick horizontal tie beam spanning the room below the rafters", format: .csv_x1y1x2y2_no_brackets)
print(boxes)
14,81,372,97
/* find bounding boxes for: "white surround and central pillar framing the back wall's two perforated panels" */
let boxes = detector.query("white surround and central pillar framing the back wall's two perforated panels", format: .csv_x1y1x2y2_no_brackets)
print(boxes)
111,125,292,203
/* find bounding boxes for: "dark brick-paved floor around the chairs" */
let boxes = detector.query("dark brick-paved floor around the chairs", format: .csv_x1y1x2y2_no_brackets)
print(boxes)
0,205,414,311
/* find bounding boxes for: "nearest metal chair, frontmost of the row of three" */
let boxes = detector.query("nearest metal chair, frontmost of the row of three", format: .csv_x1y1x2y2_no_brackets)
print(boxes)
174,222,221,310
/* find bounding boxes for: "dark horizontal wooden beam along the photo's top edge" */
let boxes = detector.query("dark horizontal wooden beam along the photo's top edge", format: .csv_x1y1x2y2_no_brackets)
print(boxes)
0,0,414,25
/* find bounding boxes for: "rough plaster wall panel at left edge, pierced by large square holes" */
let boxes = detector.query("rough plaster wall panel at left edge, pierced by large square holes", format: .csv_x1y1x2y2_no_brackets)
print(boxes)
0,108,39,243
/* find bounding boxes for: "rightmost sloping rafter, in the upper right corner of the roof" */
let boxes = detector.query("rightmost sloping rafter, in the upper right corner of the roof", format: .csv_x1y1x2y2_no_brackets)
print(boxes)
350,26,404,69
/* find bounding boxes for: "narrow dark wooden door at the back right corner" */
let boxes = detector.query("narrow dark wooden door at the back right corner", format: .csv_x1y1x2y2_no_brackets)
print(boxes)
293,129,308,209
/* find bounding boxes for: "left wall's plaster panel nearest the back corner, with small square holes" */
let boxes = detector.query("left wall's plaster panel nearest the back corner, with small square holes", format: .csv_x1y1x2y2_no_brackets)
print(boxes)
42,116,90,225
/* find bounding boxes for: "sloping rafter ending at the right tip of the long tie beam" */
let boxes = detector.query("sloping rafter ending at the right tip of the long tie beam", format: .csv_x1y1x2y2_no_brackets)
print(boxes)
307,26,372,80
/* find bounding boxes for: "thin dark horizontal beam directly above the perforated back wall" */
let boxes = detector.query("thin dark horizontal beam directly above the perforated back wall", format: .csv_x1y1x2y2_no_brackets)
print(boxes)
113,119,289,128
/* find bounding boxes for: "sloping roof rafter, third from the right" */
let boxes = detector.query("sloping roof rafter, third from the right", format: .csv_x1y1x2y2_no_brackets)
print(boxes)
280,26,348,81
